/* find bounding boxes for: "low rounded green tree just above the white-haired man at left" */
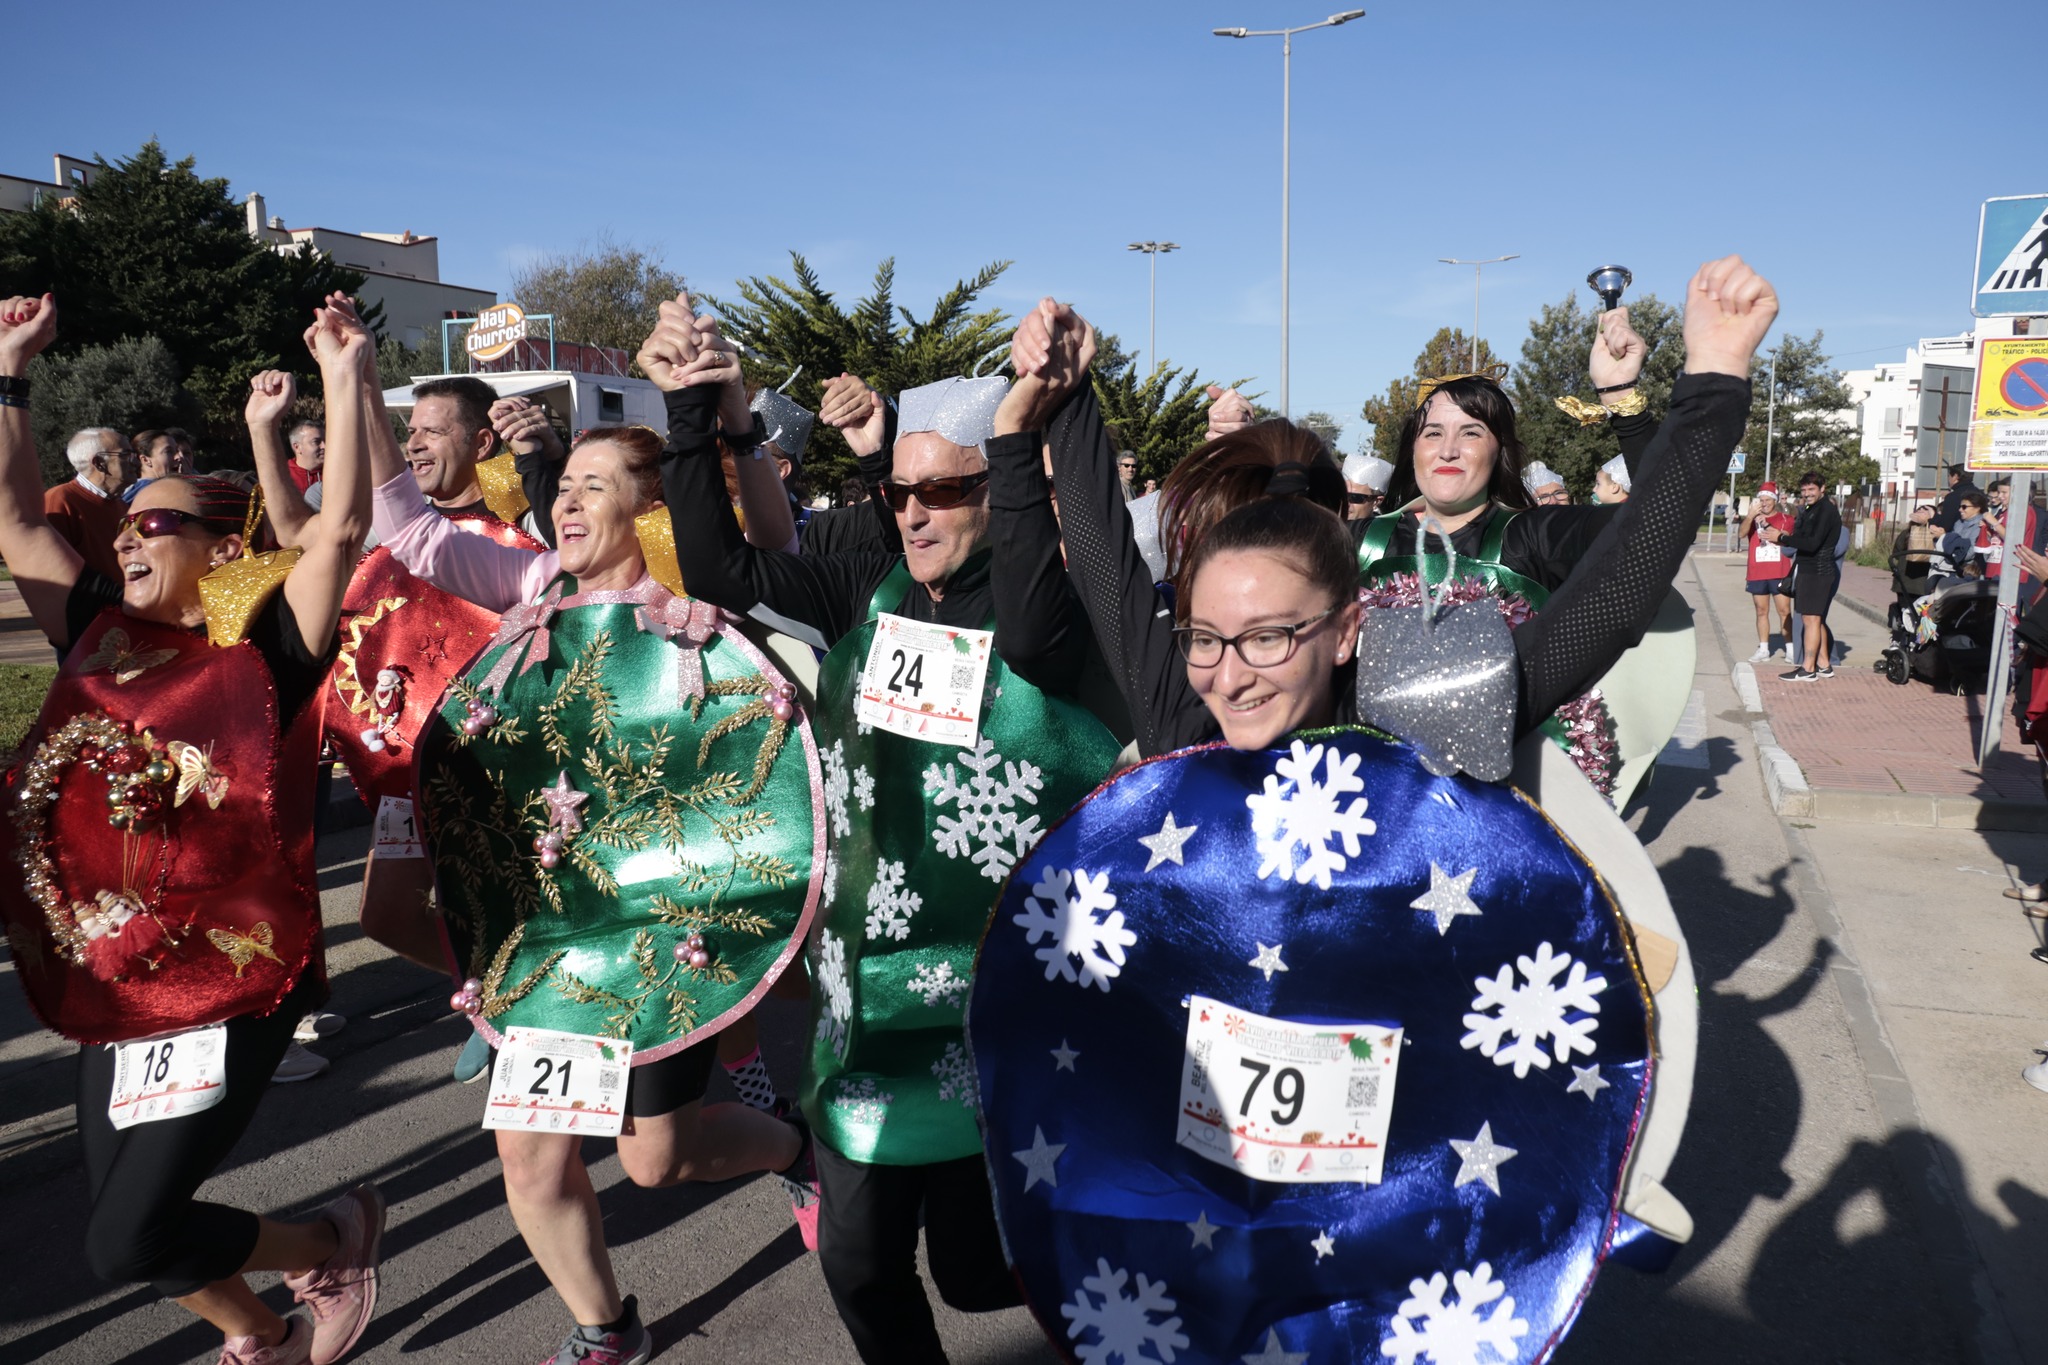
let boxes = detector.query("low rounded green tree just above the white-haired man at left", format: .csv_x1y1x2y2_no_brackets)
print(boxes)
29,336,195,485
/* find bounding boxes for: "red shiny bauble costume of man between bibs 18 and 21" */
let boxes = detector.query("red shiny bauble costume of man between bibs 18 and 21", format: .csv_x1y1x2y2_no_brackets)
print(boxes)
324,516,547,810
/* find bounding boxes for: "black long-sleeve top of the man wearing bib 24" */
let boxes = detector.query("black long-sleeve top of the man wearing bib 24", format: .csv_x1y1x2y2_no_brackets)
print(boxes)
662,387,1114,703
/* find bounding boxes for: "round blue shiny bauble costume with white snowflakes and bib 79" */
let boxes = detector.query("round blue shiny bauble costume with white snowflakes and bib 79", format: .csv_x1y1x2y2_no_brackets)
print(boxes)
969,729,1653,1365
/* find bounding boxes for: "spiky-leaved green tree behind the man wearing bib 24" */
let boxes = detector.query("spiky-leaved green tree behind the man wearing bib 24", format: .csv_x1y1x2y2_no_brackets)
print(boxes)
704,252,1014,487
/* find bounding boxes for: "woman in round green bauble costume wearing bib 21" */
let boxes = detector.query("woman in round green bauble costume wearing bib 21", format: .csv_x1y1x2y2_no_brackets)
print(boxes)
373,374,823,1361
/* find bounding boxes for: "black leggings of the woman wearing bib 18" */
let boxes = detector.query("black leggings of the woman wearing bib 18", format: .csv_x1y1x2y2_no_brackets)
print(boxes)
78,970,322,1300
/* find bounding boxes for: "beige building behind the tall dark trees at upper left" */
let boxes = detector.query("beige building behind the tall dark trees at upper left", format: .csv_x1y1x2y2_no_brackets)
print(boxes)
0,153,498,346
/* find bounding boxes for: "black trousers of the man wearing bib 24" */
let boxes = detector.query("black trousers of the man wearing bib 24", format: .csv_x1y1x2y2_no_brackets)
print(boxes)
815,1142,1024,1365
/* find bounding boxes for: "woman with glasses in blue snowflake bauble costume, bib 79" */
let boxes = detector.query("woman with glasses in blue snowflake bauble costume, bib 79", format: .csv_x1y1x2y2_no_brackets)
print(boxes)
969,258,1776,1365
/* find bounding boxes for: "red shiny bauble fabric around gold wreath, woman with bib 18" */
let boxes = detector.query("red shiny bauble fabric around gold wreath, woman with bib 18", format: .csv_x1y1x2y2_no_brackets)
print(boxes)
0,608,324,1044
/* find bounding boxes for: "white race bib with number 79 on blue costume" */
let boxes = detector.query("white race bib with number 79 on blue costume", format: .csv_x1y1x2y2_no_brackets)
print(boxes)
1176,995,1401,1185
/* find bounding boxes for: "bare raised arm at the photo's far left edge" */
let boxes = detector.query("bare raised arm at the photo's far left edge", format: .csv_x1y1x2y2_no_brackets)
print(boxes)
0,295,86,641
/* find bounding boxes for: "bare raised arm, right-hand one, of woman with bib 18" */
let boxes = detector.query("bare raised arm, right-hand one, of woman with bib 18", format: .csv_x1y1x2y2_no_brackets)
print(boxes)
280,293,376,653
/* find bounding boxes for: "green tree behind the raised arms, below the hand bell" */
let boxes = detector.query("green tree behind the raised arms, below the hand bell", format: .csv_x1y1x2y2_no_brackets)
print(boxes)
1507,291,1686,501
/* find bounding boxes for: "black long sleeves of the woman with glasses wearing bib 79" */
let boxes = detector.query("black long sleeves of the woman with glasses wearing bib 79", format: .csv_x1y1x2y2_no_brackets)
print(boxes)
1048,375,1749,755
